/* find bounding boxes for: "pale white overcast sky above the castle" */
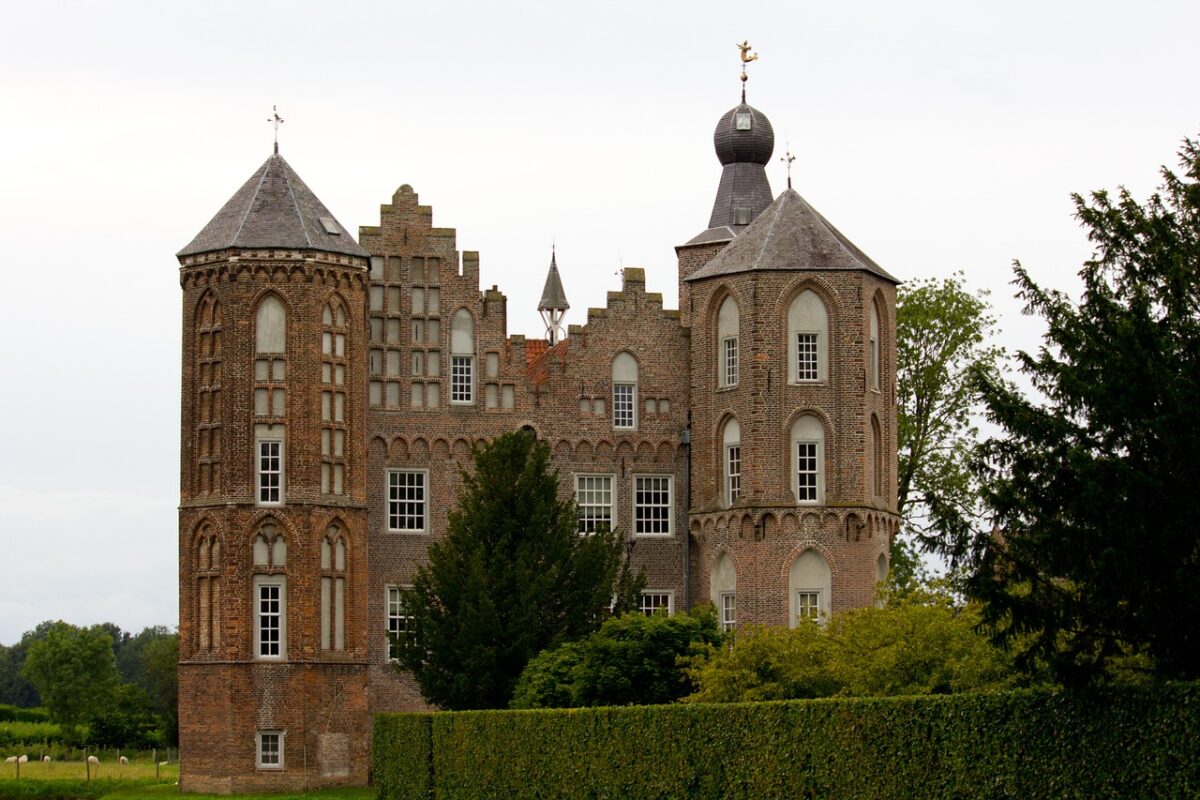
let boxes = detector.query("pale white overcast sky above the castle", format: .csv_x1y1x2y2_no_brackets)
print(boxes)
0,0,1200,643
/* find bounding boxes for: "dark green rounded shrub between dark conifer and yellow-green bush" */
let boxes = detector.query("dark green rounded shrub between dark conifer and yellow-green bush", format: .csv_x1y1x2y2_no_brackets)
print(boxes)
512,606,725,709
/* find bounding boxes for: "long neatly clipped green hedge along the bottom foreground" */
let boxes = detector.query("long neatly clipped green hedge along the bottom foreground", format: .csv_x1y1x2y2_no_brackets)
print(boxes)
374,685,1200,800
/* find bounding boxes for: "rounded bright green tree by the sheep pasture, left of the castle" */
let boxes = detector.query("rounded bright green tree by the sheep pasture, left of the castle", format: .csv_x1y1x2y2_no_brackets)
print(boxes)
22,621,118,728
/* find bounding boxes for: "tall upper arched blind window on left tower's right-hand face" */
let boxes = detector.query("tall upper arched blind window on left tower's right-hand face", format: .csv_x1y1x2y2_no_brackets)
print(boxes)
320,300,348,494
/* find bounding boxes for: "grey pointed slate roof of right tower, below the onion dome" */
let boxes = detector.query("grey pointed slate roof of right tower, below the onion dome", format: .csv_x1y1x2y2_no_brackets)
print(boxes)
686,188,899,283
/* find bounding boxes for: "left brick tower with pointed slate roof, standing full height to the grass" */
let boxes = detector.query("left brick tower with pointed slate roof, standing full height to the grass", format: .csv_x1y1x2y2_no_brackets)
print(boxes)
179,148,370,792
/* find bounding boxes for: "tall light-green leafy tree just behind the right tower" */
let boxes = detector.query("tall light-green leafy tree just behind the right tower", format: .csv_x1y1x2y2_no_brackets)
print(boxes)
892,272,1003,585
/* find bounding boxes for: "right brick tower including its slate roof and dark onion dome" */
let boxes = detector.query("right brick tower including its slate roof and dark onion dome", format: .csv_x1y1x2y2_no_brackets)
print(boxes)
677,96,898,626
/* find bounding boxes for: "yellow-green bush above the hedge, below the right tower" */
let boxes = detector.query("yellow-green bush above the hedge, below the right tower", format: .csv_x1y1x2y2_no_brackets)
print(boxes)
686,590,1014,703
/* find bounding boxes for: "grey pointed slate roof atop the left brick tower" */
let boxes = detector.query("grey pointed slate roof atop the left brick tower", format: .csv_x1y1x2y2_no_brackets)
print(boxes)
178,152,367,258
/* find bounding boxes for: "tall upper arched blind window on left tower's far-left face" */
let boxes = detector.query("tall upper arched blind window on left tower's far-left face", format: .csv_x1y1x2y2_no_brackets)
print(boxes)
192,293,221,494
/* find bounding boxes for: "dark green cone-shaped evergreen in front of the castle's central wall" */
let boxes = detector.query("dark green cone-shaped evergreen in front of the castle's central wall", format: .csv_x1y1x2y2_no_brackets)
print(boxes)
400,431,641,709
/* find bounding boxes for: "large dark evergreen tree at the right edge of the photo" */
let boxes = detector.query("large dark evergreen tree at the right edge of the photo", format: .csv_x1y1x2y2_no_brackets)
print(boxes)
941,140,1200,684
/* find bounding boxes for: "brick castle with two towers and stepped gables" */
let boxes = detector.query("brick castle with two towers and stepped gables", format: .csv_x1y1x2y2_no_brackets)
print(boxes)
179,76,899,792
